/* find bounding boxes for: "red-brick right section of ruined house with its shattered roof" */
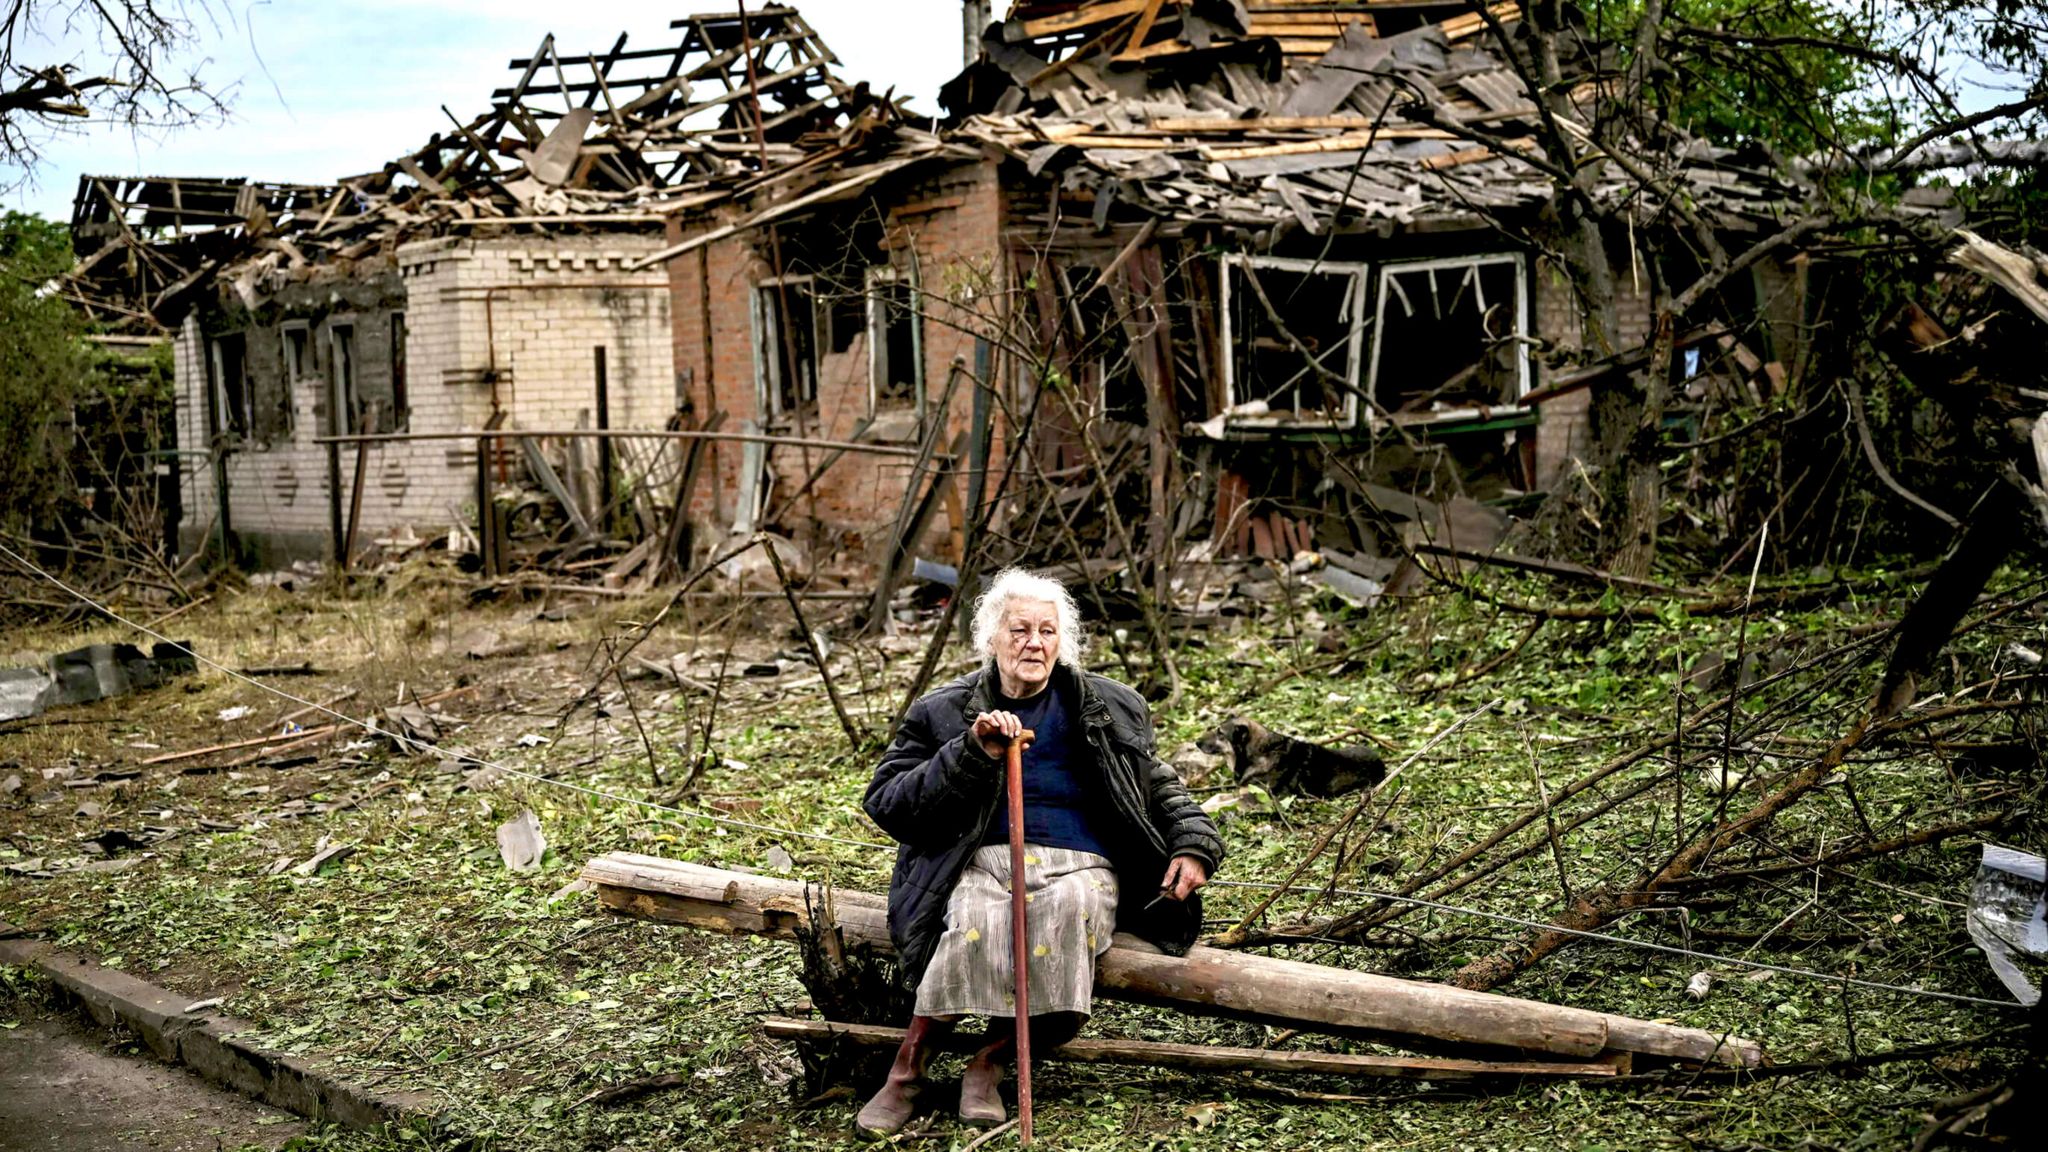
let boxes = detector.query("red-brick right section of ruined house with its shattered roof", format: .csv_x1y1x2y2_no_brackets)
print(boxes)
662,0,1800,558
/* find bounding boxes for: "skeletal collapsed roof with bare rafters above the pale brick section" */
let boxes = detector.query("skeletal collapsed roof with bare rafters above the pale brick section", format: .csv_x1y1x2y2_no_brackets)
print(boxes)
66,6,924,330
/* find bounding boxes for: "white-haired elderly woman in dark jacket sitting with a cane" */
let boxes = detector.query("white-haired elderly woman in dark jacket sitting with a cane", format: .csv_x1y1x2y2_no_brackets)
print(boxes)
854,568,1223,1140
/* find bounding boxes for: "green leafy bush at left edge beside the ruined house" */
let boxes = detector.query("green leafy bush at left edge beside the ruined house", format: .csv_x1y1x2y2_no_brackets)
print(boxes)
0,211,92,527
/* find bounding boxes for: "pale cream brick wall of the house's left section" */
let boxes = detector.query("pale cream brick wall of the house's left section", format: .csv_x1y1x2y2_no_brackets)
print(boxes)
176,234,676,564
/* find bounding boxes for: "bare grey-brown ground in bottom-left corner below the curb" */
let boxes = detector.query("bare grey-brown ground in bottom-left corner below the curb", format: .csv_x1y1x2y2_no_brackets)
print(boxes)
0,1011,305,1152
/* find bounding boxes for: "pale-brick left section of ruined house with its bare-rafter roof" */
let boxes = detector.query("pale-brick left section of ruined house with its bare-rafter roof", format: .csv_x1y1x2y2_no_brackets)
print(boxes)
68,8,895,564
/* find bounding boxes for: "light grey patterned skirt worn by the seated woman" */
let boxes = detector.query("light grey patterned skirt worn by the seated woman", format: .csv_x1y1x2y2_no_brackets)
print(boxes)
918,845,1116,1017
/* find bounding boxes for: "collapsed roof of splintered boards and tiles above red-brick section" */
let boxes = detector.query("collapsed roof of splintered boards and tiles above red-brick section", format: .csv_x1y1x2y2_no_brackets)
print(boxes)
942,0,1796,234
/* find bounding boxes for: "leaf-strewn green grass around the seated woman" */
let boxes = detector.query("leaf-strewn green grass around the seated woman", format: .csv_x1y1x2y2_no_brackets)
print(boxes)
0,553,2044,1150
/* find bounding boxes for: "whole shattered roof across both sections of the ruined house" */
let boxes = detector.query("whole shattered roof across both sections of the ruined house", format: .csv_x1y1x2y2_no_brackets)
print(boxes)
56,0,1800,328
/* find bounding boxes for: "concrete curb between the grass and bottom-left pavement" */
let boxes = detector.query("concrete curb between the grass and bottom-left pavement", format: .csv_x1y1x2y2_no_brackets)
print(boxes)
0,924,438,1129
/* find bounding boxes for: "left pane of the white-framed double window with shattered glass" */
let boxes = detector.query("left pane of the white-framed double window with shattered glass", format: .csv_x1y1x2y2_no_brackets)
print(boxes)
1223,256,1364,426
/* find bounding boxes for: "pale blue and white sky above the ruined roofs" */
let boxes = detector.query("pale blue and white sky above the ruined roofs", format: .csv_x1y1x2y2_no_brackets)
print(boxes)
0,0,961,221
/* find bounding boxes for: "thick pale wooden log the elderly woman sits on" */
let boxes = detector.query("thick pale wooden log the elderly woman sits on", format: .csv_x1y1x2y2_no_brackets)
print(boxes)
584,853,1763,1068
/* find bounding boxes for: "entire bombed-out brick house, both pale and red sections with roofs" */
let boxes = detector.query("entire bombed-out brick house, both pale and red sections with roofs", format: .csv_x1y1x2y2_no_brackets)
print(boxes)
68,0,1804,582
